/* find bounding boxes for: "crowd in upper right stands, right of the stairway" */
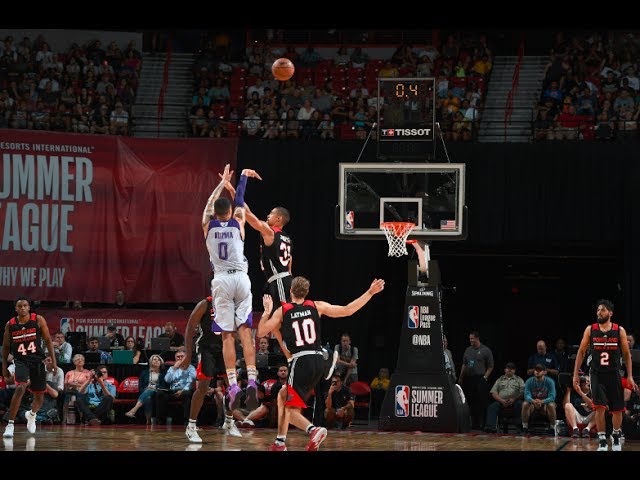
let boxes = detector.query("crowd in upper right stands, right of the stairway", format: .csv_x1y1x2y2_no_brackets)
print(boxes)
534,31,640,140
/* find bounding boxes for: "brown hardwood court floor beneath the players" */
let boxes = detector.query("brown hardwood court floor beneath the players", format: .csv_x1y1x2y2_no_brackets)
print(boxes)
0,425,640,453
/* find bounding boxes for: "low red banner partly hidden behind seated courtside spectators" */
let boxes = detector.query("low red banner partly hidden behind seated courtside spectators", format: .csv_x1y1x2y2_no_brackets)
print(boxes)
38,308,262,348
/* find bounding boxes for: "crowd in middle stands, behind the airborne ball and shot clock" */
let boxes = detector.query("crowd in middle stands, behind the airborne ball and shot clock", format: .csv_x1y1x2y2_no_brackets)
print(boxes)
189,34,493,140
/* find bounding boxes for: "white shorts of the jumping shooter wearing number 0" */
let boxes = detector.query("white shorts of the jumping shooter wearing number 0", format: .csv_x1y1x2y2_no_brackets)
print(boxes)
211,271,253,332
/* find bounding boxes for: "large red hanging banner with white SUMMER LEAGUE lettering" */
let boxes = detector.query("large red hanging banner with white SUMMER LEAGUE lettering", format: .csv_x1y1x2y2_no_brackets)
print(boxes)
0,130,237,303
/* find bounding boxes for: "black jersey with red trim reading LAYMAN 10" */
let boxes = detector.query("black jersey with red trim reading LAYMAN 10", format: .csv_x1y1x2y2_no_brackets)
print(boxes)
280,300,322,354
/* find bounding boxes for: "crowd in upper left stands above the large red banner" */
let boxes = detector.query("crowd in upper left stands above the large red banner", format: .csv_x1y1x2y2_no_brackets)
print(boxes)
0,35,142,135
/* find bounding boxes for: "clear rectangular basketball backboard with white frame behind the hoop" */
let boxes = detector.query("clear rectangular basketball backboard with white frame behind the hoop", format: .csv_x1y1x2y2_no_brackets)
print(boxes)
336,163,466,241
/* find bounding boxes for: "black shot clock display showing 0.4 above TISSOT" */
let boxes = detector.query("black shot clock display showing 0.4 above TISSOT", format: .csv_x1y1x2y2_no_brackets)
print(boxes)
378,77,435,142
